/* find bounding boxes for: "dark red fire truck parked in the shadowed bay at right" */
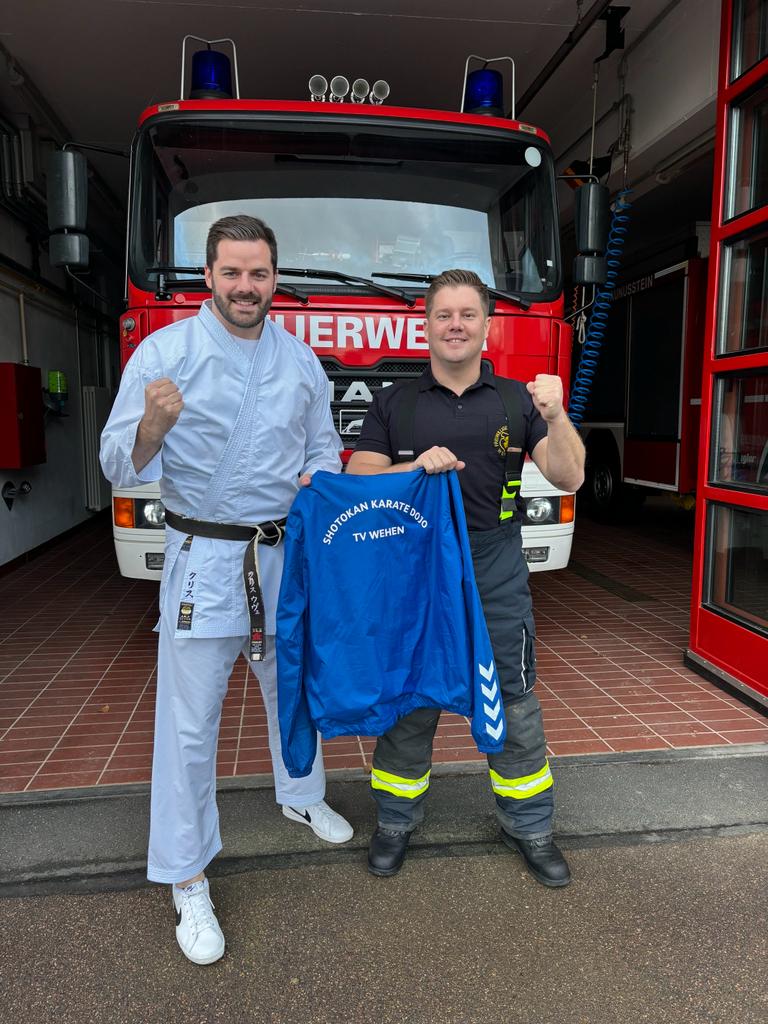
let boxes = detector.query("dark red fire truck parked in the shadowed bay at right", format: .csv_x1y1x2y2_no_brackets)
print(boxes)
580,248,709,520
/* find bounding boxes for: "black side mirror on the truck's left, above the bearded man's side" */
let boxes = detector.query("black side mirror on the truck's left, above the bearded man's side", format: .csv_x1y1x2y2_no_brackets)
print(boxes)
46,150,88,267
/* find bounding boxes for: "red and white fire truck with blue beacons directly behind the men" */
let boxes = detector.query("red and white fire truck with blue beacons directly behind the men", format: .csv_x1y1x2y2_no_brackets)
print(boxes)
49,51,606,579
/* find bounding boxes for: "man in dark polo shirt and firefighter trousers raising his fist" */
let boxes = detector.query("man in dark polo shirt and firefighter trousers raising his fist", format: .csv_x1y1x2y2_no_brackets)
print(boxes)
348,270,584,886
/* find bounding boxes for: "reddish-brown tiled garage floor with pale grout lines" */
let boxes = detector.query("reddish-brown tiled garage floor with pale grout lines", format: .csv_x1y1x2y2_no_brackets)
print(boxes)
0,501,768,793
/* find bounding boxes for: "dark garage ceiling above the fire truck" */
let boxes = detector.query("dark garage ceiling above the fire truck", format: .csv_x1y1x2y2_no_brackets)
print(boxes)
0,0,675,197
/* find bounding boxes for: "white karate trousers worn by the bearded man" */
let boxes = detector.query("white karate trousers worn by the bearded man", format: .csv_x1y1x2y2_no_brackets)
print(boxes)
146,615,326,883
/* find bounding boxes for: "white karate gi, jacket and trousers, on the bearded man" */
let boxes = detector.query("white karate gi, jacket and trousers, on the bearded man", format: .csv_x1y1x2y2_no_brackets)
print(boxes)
101,301,341,883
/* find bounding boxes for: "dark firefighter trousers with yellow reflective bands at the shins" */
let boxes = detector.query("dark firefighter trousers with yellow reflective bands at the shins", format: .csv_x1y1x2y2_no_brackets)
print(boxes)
371,520,554,839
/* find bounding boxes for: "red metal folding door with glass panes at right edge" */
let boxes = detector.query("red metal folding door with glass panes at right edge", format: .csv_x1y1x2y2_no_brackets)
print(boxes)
686,0,768,705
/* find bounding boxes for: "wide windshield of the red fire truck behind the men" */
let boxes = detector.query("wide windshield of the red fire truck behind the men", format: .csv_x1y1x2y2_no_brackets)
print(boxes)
129,114,560,301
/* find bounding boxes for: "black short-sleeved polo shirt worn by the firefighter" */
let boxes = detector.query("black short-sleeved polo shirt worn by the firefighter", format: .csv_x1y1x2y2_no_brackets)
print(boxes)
355,362,547,529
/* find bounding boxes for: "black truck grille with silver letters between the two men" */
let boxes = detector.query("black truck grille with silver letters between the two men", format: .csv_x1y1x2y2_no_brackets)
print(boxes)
321,359,429,449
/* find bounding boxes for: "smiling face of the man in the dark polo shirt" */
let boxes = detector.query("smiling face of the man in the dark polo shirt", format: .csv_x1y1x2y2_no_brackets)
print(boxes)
427,285,490,372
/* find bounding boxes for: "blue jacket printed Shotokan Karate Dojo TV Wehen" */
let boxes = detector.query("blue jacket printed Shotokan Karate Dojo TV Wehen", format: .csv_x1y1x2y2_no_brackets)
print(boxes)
276,470,506,778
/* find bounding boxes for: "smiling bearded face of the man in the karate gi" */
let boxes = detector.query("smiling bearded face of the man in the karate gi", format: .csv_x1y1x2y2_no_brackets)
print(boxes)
205,239,278,340
